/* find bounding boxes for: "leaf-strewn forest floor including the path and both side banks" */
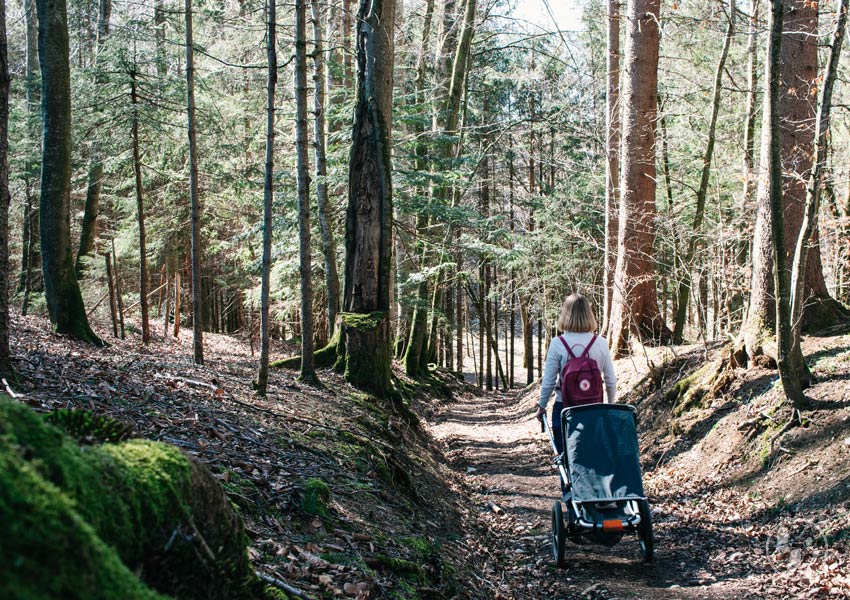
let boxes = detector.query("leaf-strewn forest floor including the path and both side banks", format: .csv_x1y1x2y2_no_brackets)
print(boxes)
6,315,850,599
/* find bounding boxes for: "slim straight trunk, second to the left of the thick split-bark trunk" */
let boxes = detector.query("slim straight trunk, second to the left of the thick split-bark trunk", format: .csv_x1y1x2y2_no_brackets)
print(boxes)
295,0,316,381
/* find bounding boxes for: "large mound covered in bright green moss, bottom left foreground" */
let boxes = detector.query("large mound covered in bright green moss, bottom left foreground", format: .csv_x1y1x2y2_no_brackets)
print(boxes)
0,397,264,599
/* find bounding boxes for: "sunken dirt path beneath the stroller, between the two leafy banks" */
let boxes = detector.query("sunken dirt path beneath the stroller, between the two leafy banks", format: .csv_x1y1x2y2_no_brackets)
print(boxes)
431,390,763,600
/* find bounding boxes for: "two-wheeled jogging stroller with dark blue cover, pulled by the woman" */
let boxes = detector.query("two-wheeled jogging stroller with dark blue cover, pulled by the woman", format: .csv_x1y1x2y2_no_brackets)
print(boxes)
543,403,654,569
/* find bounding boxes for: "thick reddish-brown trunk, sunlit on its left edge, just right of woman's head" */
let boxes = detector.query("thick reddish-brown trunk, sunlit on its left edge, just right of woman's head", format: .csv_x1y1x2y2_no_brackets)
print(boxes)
608,0,672,356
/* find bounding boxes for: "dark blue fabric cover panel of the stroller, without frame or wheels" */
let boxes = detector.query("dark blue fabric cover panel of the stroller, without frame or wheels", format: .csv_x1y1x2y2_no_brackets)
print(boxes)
561,404,644,502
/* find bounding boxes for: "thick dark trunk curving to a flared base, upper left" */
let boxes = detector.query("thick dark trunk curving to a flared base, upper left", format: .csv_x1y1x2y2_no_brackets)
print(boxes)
36,0,103,346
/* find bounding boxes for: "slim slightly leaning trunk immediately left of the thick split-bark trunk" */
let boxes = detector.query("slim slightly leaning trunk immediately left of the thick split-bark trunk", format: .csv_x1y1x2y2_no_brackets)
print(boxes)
310,0,340,337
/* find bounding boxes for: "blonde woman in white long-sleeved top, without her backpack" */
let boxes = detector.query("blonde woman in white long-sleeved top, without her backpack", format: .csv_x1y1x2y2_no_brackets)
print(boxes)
534,294,617,462
